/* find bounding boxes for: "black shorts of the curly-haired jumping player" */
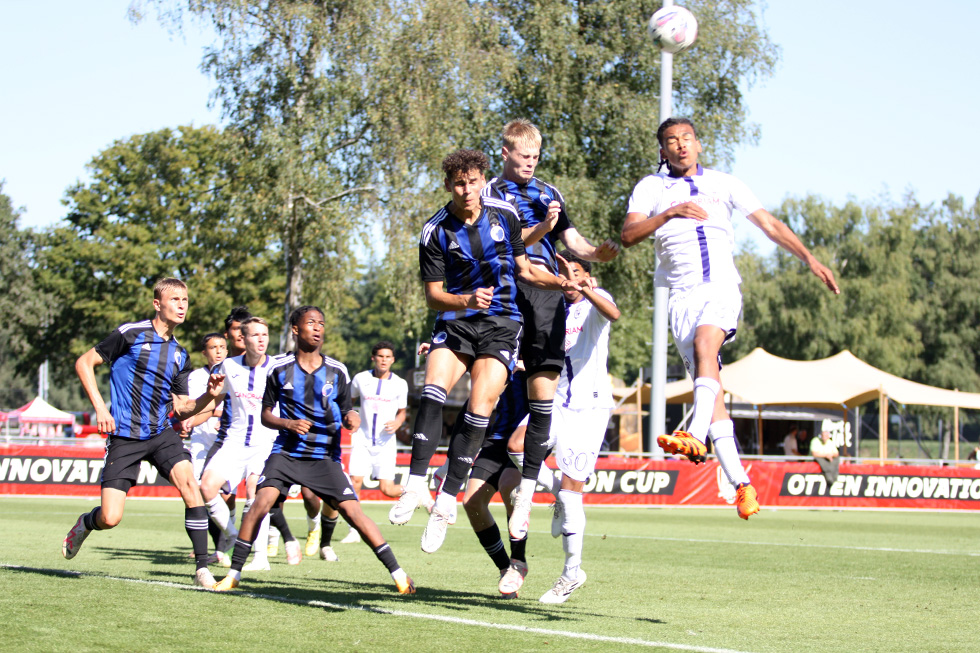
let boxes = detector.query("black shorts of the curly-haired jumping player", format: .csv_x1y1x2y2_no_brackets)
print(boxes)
431,315,520,370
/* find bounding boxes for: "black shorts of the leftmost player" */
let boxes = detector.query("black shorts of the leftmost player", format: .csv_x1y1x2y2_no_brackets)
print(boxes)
101,429,191,492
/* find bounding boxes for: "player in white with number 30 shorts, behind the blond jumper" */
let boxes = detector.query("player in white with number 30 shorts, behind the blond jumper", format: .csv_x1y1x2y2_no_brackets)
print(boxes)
540,251,619,603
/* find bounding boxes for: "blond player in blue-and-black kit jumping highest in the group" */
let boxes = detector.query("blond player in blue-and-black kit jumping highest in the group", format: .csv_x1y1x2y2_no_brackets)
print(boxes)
483,120,619,539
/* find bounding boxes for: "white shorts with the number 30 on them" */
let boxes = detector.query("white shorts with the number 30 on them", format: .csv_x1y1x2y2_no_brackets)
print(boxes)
549,401,612,483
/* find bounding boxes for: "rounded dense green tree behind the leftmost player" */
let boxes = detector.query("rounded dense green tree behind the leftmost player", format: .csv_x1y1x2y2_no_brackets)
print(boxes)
28,127,283,382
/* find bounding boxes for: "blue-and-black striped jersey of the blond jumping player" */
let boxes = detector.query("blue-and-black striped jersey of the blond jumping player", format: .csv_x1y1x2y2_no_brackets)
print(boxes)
483,177,574,274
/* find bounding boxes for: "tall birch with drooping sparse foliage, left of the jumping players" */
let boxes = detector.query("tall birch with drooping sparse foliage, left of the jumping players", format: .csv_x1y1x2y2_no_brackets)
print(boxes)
138,0,512,348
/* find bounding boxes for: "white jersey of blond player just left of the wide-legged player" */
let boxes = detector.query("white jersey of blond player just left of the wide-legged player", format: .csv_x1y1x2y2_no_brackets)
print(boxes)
215,354,279,447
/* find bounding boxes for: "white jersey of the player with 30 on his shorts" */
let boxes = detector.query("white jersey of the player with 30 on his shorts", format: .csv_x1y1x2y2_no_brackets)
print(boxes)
555,288,615,410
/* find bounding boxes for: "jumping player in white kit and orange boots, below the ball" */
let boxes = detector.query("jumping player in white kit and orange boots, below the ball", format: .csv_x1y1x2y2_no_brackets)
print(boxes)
622,118,840,519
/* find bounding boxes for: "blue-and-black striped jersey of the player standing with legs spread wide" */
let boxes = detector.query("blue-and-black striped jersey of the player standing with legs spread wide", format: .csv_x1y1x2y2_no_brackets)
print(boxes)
262,353,351,462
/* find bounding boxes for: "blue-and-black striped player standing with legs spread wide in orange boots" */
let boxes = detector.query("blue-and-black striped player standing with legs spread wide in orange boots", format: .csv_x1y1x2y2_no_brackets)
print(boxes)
215,306,415,594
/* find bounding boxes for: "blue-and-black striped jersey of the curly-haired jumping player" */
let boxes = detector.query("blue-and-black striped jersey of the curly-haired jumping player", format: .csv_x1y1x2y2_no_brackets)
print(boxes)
419,197,524,322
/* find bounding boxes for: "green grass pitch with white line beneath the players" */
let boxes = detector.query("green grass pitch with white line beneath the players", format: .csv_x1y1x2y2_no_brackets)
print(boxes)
0,497,980,652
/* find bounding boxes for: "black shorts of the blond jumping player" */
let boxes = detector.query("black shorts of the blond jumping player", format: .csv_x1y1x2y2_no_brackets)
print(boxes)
517,283,565,374
